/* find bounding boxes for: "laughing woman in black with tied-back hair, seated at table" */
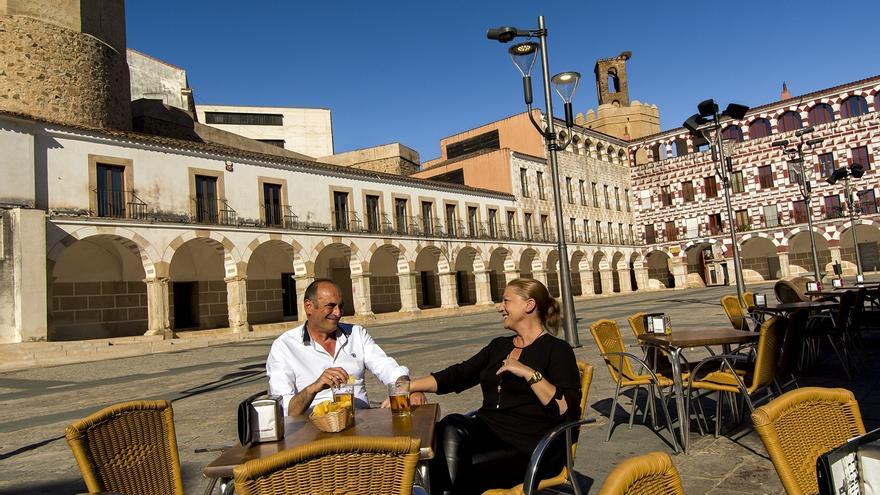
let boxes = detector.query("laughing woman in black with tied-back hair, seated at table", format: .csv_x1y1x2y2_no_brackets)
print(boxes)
411,278,580,494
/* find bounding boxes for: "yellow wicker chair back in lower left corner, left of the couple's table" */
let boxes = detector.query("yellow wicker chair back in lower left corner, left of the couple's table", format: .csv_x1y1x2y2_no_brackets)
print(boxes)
65,400,183,495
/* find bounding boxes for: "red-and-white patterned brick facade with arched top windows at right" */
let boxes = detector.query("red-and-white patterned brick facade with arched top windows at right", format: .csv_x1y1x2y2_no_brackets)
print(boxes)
629,76,880,287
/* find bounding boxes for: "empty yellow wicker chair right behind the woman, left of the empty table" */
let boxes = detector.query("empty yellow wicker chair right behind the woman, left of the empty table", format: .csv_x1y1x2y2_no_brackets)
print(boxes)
590,320,678,452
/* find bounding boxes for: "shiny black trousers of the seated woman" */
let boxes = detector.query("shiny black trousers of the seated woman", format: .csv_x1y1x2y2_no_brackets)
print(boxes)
429,414,561,495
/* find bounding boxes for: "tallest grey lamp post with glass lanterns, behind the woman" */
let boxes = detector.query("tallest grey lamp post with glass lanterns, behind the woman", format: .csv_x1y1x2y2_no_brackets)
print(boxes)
486,16,581,347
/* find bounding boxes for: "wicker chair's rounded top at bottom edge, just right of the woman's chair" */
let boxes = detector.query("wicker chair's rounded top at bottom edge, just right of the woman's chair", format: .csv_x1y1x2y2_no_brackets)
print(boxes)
599,452,684,495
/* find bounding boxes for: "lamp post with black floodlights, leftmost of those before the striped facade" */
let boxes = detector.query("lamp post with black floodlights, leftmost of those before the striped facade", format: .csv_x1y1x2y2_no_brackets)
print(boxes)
684,99,749,306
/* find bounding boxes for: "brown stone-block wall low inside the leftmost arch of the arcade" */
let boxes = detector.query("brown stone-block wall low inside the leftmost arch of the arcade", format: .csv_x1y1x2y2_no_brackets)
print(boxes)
50,282,147,340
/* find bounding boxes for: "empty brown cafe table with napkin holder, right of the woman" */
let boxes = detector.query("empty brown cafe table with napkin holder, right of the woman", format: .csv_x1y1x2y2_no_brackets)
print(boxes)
639,328,758,454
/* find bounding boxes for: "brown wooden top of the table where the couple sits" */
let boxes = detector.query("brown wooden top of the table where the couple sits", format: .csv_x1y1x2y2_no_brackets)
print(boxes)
203,404,440,478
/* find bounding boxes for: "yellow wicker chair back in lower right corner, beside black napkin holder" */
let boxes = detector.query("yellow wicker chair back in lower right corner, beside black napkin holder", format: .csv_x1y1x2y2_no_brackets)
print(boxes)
752,387,865,495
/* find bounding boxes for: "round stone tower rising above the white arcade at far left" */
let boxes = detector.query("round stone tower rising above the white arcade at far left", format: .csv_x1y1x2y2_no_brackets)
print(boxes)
0,0,131,129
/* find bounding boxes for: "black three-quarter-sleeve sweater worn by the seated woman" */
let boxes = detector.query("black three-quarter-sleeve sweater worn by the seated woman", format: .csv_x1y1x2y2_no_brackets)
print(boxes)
432,334,581,455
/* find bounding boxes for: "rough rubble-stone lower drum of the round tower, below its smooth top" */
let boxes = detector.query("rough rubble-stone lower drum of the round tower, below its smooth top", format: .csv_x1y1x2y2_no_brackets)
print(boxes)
0,16,131,129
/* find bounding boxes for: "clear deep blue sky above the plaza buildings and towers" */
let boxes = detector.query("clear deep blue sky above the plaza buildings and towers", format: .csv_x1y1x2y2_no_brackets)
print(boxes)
126,0,880,161
